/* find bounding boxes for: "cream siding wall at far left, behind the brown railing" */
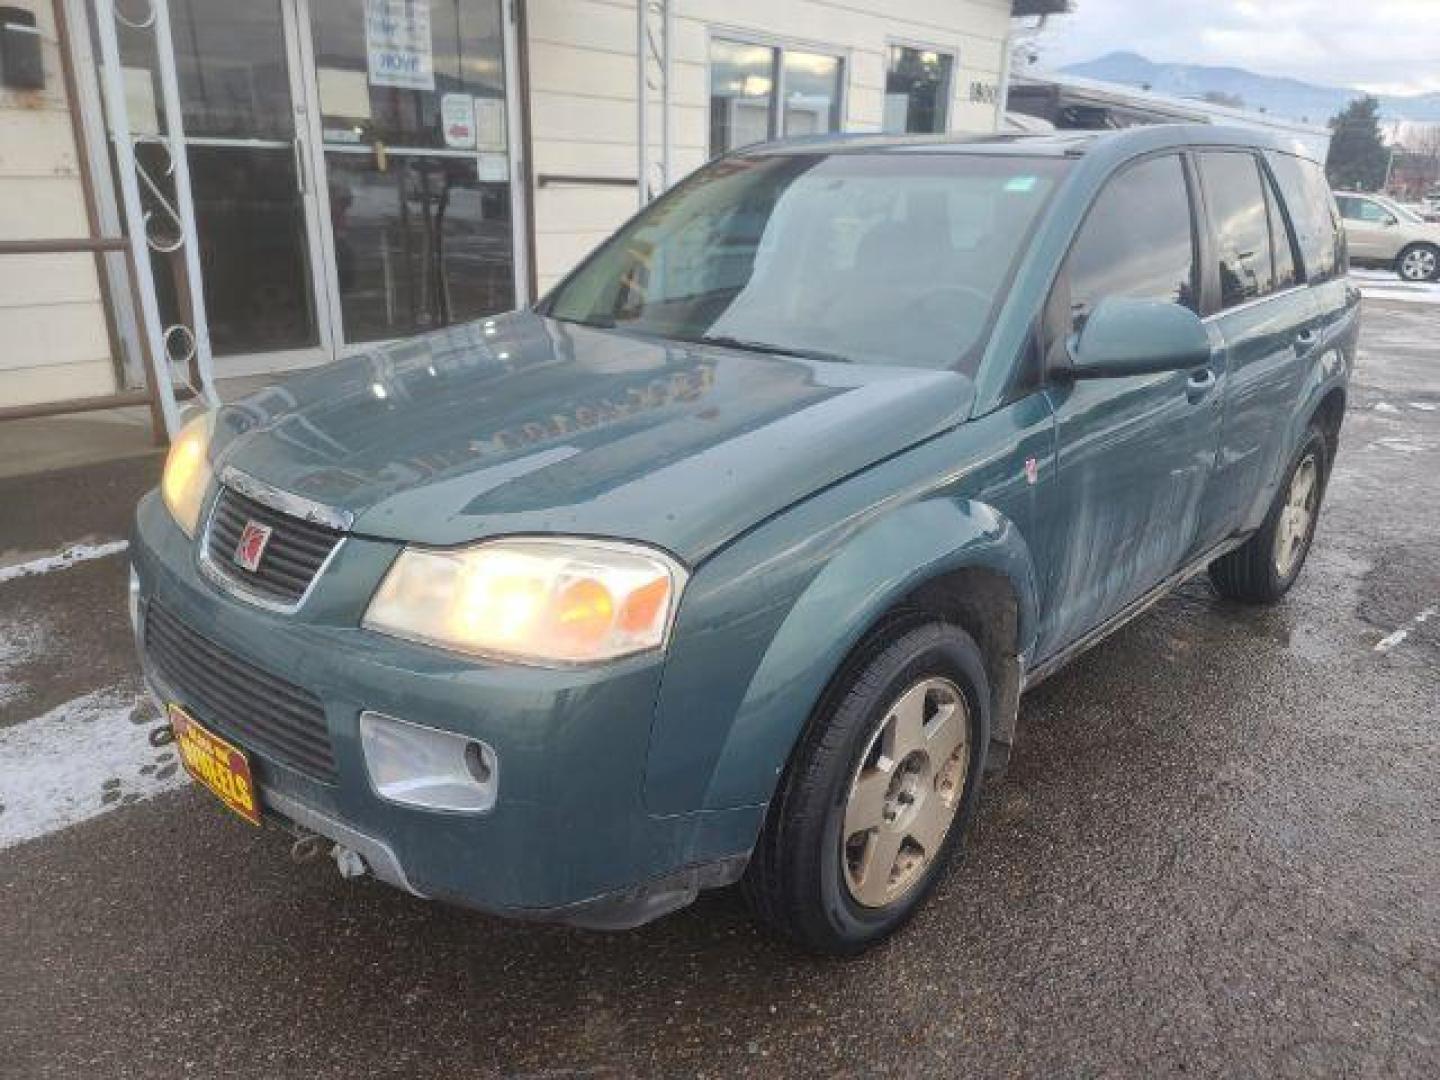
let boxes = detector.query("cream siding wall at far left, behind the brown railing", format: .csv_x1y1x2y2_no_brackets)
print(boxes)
0,0,115,406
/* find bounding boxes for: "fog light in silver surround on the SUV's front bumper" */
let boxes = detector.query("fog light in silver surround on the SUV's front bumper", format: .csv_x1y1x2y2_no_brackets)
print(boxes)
360,713,500,814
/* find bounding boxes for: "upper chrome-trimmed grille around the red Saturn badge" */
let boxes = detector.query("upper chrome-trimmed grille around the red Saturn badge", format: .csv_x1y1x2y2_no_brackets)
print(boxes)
204,487,341,605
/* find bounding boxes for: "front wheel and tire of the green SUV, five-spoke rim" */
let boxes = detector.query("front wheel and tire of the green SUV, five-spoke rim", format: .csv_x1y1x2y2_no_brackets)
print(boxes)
743,616,991,956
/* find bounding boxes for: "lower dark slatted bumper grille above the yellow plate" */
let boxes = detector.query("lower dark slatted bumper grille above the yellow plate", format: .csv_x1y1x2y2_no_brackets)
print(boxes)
145,600,336,782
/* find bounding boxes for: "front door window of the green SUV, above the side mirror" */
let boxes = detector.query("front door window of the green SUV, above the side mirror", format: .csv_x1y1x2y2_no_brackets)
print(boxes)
1068,154,1192,328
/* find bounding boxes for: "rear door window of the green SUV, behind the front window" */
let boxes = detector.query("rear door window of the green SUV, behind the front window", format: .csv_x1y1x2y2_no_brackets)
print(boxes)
1200,153,1274,308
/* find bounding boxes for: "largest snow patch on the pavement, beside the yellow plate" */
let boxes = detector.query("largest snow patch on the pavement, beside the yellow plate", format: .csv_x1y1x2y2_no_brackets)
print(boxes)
0,690,189,850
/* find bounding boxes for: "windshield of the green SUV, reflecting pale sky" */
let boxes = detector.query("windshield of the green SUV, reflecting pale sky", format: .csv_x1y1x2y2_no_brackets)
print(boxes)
543,153,1067,374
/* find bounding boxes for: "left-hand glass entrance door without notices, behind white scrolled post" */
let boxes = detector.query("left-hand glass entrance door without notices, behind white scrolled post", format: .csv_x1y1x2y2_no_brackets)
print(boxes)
117,0,331,379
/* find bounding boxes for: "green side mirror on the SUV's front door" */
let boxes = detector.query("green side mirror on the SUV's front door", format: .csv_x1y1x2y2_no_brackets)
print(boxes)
1070,297,1210,379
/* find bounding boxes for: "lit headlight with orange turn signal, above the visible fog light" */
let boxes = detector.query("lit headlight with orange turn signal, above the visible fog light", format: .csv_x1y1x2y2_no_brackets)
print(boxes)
364,539,685,664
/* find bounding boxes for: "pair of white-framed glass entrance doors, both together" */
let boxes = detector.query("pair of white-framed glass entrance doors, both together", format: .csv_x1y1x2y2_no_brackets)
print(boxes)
109,0,524,379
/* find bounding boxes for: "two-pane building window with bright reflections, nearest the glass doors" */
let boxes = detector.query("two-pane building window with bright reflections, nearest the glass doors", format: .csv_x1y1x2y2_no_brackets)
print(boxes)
710,37,845,157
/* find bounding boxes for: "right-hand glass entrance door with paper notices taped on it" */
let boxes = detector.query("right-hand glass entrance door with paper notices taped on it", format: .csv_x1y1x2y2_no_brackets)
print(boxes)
298,0,518,347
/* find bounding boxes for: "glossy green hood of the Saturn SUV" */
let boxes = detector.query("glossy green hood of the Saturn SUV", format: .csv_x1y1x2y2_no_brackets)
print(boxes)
212,312,973,563
